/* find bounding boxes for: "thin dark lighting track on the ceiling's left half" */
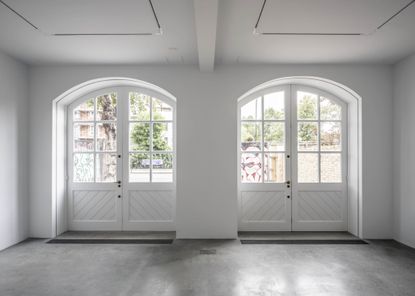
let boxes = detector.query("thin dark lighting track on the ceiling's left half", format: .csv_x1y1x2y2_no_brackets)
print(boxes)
0,0,162,37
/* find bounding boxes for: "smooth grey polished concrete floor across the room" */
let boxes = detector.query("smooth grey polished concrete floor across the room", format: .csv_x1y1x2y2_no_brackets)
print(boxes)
0,240,415,296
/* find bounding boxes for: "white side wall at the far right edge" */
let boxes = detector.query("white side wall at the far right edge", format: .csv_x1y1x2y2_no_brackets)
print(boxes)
393,55,415,247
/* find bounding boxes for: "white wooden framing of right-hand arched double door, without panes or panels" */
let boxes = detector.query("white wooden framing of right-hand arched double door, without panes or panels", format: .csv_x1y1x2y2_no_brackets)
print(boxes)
237,82,352,231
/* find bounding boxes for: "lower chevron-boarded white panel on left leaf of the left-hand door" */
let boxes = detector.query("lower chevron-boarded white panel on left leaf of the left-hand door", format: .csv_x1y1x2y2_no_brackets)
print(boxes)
72,190,117,222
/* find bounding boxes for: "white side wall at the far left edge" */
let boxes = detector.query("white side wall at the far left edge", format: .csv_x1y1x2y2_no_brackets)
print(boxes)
0,52,29,250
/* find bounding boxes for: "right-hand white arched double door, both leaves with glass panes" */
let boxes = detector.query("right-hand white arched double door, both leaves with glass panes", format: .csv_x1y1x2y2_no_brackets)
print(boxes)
238,85,348,231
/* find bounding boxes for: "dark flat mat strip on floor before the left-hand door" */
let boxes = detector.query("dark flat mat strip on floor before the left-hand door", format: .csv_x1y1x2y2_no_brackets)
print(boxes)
46,238,173,245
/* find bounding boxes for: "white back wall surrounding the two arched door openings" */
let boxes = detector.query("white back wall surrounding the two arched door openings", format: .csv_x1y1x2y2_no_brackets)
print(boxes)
30,65,392,238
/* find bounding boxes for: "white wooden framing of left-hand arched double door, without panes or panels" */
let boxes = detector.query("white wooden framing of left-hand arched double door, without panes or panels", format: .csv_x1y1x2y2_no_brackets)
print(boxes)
65,86,177,231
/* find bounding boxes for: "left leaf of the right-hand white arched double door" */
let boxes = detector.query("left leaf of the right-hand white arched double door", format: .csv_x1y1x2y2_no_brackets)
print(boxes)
238,87,291,231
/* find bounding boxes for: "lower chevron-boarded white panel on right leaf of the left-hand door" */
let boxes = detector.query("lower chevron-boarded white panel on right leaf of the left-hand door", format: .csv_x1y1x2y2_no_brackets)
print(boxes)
128,190,174,222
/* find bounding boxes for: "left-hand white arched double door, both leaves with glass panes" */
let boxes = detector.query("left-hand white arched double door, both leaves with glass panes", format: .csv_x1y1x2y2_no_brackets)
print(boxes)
67,87,176,231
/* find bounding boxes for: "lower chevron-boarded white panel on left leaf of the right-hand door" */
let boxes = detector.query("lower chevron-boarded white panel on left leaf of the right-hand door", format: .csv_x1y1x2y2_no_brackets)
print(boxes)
241,191,286,222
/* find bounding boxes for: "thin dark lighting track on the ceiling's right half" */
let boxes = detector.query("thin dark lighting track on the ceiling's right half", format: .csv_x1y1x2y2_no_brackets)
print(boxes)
253,0,415,36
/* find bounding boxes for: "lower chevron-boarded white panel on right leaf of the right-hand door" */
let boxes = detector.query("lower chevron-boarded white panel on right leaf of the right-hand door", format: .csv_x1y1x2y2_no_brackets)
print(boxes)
297,191,345,221
